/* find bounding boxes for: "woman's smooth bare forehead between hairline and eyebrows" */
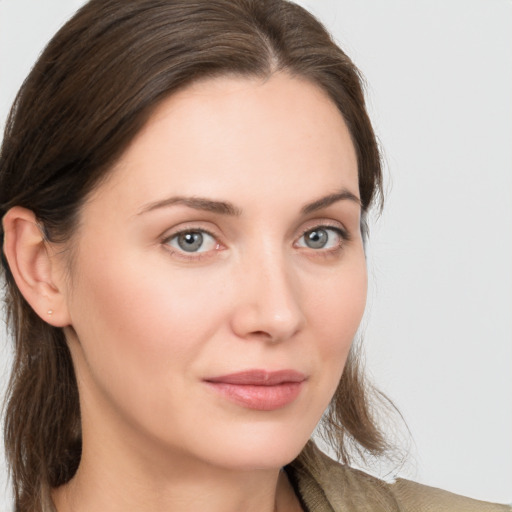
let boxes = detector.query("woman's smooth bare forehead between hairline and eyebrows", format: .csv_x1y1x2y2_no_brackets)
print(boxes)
86,73,358,213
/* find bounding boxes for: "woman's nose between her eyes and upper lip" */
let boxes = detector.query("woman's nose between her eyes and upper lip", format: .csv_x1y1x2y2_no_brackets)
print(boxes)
231,249,305,342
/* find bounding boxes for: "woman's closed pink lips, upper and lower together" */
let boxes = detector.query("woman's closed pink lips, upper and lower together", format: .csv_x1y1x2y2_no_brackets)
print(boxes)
204,370,306,411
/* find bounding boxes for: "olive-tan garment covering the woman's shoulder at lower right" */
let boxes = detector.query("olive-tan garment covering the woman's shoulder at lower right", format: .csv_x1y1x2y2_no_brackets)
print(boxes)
286,443,512,512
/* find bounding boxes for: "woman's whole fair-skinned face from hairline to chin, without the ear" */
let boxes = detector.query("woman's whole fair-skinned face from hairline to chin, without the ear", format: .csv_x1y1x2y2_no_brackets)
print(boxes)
60,73,366,469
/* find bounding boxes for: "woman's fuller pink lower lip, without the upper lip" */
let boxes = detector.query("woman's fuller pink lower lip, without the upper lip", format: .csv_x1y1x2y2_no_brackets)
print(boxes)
207,382,303,411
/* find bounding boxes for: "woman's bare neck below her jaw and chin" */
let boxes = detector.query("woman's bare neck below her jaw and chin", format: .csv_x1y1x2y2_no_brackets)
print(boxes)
53,420,301,512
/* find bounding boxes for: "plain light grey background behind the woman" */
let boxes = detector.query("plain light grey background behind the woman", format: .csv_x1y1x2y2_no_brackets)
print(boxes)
0,0,512,510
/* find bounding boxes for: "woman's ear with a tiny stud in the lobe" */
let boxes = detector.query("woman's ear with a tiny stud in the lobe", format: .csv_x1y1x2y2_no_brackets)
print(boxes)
3,206,71,327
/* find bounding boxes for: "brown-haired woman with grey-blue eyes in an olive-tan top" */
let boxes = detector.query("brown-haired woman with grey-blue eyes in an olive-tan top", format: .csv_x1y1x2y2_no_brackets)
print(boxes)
0,0,508,512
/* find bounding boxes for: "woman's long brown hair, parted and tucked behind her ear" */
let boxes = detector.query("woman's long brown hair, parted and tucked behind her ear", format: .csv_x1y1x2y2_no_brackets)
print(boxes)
0,0,386,511
